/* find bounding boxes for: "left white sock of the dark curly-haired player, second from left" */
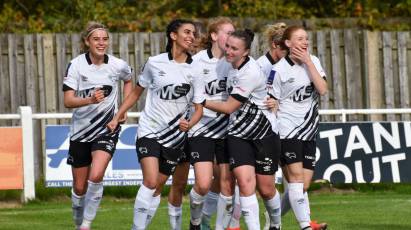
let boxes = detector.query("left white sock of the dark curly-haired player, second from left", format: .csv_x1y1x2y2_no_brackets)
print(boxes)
132,184,156,230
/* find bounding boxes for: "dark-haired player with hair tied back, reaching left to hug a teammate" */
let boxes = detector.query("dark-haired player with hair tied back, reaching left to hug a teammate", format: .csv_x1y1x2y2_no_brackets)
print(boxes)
203,30,280,229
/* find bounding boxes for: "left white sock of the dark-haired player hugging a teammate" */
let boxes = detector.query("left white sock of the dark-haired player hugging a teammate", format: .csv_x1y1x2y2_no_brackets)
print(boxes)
240,193,260,230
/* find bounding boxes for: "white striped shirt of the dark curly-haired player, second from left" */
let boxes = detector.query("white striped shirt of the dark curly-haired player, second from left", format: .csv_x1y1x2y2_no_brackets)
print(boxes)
137,53,204,148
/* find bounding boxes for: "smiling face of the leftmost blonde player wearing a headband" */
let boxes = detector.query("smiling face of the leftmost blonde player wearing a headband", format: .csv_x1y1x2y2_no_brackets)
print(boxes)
86,29,109,58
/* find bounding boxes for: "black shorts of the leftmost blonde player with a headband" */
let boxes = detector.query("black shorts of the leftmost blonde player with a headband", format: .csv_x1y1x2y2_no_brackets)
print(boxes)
67,132,119,168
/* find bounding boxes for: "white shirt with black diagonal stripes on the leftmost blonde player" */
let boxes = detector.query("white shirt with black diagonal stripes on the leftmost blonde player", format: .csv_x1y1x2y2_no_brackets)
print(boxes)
63,53,132,142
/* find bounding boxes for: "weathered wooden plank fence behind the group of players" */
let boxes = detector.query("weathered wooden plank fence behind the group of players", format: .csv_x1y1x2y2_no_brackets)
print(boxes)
0,29,411,121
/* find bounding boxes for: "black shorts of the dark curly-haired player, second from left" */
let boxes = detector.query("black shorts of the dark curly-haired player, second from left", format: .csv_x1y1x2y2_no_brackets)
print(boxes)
136,137,184,176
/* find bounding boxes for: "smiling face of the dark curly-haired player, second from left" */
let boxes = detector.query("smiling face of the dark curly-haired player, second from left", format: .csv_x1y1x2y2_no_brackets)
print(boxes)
170,23,195,51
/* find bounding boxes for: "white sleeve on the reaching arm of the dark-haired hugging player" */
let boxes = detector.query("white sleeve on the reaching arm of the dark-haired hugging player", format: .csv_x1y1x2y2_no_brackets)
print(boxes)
230,71,259,102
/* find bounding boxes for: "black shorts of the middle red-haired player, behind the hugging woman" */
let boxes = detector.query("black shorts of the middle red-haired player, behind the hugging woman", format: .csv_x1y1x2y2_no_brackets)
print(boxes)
187,137,229,165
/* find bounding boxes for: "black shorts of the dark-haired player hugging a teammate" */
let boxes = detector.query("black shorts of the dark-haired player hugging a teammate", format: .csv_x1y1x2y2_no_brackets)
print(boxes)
227,134,281,175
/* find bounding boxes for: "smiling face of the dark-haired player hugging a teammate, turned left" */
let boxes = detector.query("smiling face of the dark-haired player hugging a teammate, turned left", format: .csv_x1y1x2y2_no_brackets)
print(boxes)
225,36,249,68
